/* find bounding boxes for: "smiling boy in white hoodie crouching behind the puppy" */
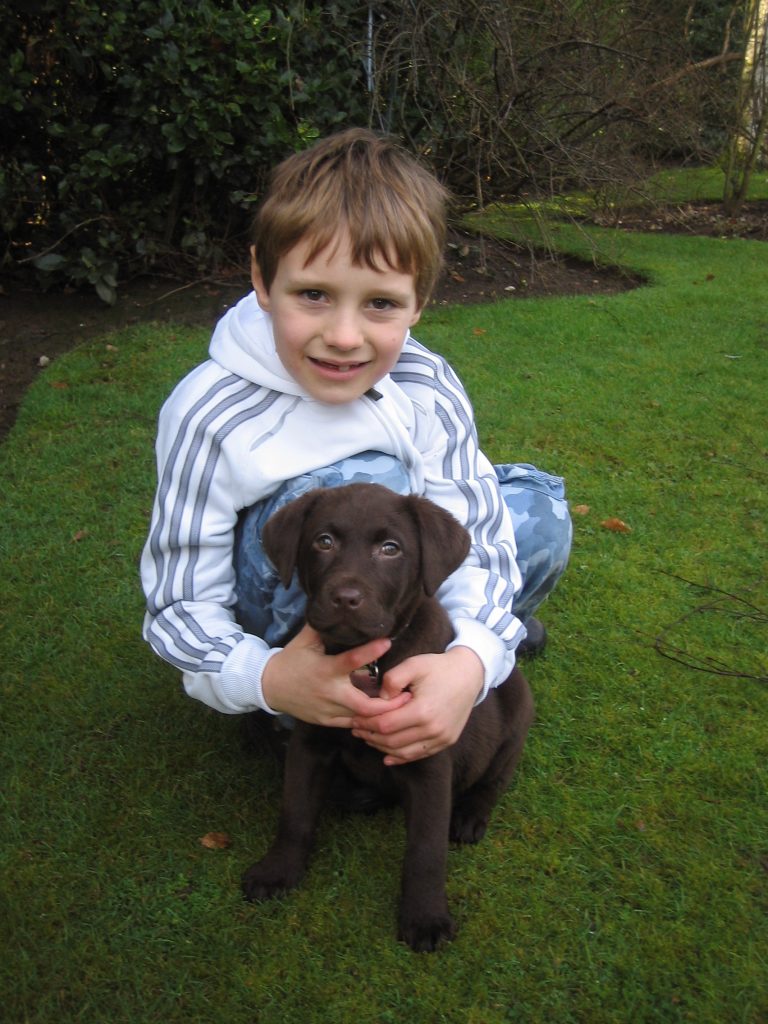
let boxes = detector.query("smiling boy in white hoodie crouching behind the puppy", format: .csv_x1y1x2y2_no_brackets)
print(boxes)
141,129,570,765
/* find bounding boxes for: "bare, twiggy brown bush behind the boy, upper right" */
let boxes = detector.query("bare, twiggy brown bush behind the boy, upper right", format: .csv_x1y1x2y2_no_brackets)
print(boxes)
367,0,749,205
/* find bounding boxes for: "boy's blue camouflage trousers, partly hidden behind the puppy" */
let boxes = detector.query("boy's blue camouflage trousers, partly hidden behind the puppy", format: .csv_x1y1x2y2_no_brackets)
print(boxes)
234,452,572,647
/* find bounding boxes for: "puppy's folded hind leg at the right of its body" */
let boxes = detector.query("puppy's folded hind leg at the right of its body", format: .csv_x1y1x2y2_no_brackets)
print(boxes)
451,669,534,843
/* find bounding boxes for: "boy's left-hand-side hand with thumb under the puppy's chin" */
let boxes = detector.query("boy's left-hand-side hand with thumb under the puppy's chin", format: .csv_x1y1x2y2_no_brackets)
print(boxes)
261,626,412,729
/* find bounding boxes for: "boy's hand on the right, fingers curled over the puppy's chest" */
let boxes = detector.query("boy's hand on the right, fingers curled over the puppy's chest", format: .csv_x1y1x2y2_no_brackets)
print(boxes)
352,647,484,767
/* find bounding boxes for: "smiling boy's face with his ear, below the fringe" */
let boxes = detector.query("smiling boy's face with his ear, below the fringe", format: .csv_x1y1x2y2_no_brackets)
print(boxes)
251,234,421,403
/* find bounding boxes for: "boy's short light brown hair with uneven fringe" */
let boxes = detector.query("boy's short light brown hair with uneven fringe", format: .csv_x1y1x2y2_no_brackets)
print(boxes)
253,128,447,307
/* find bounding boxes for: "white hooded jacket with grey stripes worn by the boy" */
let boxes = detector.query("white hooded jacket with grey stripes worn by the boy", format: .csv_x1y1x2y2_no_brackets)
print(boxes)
141,293,525,714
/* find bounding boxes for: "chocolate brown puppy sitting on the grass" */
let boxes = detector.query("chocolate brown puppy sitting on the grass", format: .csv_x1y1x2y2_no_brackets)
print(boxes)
243,483,534,950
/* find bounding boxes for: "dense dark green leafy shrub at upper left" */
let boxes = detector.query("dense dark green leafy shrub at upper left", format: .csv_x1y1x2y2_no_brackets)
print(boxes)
0,0,366,301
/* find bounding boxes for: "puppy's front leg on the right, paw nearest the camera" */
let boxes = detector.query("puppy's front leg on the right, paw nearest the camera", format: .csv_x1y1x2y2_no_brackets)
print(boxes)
391,752,456,952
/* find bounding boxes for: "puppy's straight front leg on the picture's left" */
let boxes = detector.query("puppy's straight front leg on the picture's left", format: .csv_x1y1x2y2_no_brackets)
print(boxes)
242,723,334,900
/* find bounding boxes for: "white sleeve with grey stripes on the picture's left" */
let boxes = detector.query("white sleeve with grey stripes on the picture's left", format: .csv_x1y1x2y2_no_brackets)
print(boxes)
141,375,278,713
